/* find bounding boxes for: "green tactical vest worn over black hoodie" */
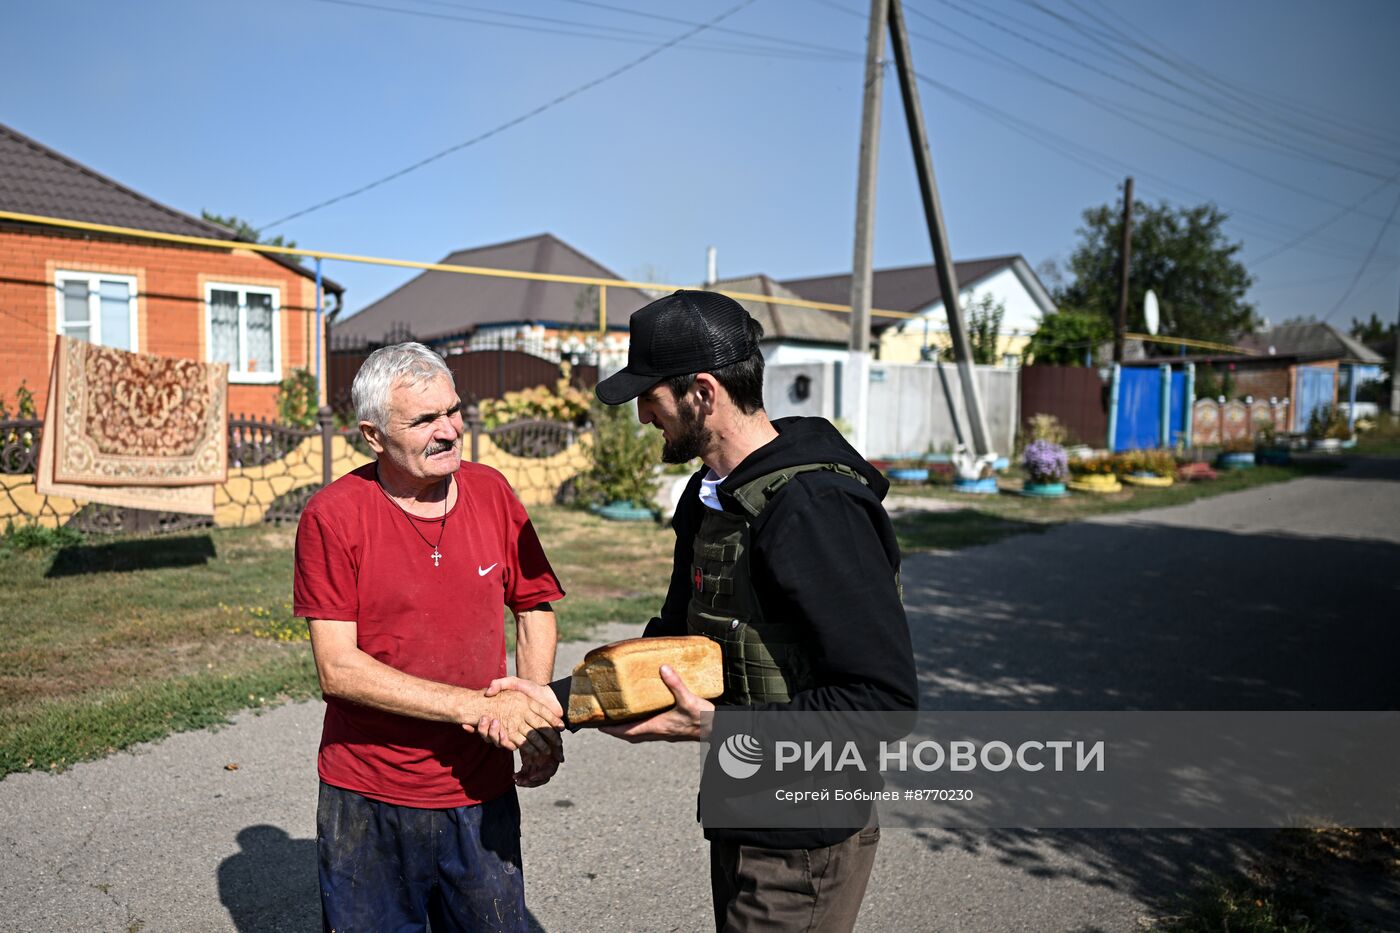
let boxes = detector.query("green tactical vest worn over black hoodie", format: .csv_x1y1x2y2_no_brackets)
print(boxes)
686,464,868,706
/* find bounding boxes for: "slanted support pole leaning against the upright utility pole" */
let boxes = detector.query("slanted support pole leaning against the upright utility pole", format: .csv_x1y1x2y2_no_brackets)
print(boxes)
889,0,991,455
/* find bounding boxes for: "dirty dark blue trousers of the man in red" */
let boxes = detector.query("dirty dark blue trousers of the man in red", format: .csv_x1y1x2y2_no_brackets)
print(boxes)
316,783,529,933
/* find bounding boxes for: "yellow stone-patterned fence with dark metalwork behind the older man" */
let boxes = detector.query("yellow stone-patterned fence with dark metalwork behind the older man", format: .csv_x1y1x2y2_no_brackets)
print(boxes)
0,406,588,534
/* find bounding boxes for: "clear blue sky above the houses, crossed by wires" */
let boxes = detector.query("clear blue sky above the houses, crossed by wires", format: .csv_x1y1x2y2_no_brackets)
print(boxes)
10,0,1400,325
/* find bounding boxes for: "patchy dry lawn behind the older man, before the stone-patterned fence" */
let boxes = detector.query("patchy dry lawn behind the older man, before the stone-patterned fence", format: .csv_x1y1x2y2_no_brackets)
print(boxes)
0,509,673,776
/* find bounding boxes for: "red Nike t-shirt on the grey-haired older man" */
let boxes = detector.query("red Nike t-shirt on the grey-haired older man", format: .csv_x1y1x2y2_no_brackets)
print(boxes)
293,462,564,808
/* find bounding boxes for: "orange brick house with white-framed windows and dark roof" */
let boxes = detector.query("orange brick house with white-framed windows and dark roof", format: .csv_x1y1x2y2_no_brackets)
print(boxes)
0,125,344,417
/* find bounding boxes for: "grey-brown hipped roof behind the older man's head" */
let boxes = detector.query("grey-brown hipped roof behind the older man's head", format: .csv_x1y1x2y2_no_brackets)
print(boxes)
333,233,651,340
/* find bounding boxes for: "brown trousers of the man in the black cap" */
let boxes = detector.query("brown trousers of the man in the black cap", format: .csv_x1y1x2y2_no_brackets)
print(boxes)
710,827,879,933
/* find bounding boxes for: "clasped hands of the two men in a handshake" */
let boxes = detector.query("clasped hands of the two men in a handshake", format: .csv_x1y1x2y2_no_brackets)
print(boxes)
462,677,564,787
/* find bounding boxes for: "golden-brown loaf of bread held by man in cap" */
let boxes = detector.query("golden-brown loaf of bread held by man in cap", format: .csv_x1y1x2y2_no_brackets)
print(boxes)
568,635,724,726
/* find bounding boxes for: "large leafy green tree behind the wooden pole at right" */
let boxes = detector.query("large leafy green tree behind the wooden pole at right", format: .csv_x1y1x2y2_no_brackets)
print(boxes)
1056,202,1259,343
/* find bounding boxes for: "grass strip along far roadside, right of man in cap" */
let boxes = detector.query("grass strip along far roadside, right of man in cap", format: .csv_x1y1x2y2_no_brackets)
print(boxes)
890,461,1341,552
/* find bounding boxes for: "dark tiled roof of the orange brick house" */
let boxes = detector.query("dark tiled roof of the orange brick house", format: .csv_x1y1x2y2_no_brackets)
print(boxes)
0,123,344,294
